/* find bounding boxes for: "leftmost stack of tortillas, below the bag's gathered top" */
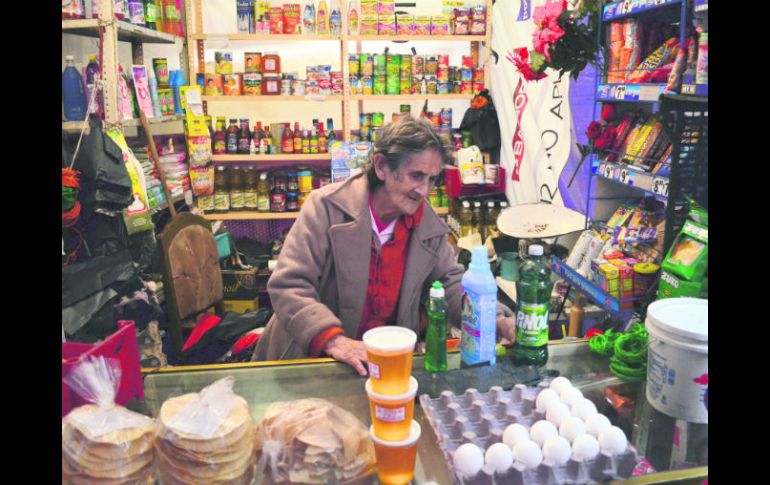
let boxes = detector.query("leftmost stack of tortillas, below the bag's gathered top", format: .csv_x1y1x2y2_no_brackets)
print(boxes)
62,404,155,485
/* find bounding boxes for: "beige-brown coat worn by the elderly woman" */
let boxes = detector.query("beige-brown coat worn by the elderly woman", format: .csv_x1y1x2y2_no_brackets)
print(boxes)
252,170,463,360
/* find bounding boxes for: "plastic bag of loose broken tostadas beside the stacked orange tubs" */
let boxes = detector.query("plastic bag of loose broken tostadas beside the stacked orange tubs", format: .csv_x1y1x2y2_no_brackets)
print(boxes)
256,399,375,484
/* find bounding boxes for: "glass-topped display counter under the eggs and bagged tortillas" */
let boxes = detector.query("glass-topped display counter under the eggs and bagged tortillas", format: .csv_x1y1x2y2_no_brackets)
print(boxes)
136,339,708,485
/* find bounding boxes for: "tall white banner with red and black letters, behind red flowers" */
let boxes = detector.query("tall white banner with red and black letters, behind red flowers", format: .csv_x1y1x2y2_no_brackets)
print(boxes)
490,0,573,205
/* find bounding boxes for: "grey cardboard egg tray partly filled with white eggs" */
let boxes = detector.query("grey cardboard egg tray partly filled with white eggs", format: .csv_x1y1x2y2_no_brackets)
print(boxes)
420,381,639,485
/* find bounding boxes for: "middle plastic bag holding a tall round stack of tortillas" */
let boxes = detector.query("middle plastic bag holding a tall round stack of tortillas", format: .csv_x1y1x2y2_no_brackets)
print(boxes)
155,376,254,485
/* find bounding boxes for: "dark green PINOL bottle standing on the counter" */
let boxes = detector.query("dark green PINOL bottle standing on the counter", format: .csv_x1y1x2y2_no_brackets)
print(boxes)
511,244,553,366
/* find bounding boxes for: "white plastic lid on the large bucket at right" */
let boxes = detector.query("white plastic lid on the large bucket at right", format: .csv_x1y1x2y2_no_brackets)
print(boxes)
646,298,709,342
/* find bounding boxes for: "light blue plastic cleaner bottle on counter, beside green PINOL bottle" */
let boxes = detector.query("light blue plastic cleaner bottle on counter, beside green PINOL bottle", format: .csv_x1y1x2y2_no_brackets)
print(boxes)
460,246,497,366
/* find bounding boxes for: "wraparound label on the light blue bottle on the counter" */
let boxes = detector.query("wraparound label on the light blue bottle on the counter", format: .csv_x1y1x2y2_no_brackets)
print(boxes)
460,290,497,365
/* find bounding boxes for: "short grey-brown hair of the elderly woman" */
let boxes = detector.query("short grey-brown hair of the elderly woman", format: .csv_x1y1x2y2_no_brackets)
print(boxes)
364,116,452,191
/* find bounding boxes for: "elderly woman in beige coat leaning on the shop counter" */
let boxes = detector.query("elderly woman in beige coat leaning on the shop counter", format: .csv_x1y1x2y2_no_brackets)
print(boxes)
252,117,515,376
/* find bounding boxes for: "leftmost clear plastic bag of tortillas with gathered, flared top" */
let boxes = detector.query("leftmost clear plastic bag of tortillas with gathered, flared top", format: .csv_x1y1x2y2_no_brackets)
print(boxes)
62,356,155,484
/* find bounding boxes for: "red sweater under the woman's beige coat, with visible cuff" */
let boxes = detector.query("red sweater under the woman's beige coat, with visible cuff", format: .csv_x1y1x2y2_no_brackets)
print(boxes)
310,202,425,357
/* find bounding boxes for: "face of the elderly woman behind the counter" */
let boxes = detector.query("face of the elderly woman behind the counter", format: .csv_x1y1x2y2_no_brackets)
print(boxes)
375,149,442,215
